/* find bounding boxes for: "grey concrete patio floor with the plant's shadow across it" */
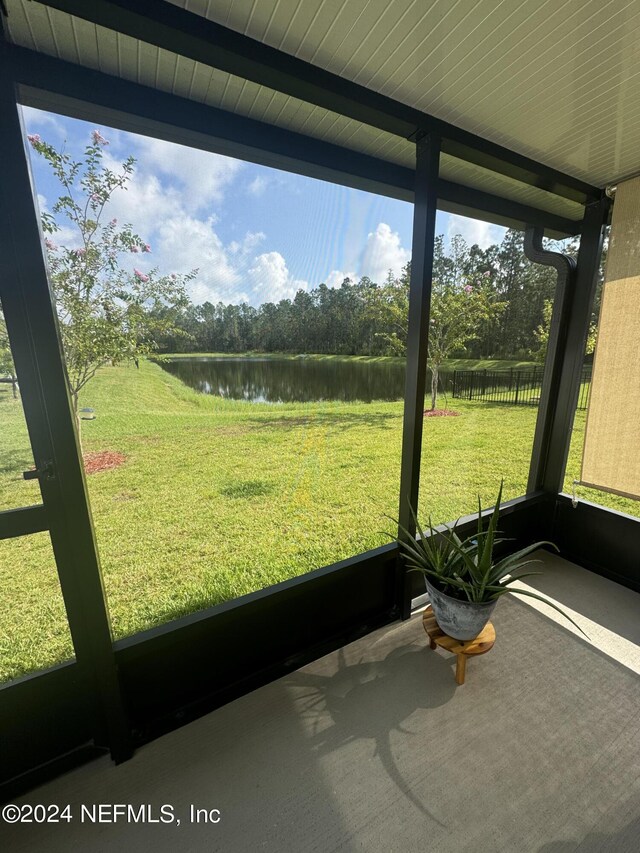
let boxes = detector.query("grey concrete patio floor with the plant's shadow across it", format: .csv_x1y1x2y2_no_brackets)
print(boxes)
0,555,640,853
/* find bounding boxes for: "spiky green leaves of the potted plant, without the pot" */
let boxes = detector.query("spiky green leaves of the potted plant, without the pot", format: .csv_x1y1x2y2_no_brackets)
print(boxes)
397,480,587,637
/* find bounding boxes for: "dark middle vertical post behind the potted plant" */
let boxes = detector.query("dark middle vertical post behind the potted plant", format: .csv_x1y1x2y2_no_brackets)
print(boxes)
397,134,440,619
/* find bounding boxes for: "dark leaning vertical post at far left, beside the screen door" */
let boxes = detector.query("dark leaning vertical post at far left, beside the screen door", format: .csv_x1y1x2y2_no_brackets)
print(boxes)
0,48,131,761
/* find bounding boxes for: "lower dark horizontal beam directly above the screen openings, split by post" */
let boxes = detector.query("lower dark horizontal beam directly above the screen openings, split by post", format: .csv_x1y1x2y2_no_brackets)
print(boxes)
7,46,581,237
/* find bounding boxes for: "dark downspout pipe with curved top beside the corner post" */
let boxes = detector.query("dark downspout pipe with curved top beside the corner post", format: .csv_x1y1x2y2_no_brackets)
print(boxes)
524,228,576,493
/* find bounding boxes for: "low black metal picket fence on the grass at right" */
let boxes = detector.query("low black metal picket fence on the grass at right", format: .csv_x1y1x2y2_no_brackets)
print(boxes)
452,364,591,409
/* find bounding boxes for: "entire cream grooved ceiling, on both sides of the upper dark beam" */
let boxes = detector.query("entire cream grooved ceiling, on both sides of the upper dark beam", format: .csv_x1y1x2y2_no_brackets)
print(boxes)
7,0,640,225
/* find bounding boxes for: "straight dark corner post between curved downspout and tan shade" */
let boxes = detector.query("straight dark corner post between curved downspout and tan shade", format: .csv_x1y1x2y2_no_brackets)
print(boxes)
538,199,610,494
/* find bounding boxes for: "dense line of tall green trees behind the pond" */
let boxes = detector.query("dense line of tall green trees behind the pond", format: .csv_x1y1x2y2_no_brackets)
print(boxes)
158,231,566,359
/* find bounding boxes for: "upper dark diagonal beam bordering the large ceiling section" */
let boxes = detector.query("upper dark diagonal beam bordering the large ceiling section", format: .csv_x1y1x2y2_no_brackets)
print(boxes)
39,0,599,203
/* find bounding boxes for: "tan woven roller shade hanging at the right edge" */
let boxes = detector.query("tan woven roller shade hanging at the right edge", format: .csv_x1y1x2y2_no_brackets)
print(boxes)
581,177,640,498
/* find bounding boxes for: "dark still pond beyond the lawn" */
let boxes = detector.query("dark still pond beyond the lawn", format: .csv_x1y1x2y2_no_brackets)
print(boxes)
160,356,456,403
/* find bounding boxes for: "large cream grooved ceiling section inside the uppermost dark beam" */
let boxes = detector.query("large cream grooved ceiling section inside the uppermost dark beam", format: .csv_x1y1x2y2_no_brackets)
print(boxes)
168,0,640,186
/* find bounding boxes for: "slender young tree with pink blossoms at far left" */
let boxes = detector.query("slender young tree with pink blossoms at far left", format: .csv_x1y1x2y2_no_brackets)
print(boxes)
28,130,197,412
